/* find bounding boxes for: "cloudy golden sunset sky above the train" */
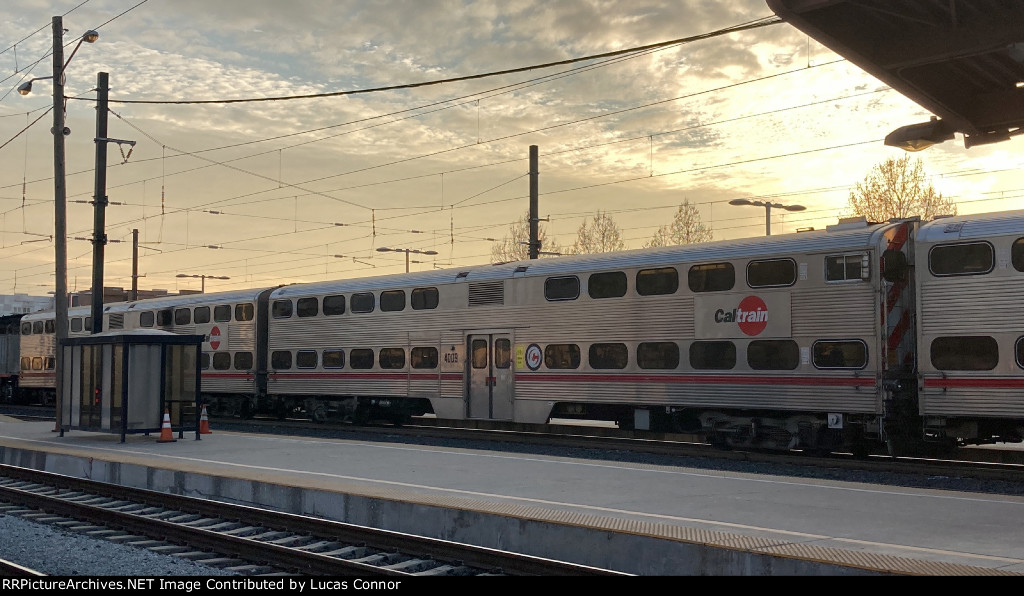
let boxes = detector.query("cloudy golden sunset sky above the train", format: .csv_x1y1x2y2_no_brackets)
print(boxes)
0,0,1024,295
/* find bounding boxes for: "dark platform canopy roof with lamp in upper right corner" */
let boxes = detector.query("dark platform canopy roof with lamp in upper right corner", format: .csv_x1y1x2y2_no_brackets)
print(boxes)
767,0,1024,151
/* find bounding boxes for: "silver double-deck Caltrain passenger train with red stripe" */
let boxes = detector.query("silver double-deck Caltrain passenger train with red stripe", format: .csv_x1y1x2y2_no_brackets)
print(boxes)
2,211,1024,455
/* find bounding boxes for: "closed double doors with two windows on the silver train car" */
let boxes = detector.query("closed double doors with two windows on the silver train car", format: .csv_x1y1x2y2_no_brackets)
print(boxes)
466,333,515,420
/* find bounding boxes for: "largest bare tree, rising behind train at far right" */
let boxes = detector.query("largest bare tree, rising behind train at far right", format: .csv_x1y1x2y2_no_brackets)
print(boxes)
848,156,956,221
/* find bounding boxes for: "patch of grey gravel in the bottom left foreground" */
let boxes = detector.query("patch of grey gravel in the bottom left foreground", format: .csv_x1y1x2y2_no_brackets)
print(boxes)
0,515,240,577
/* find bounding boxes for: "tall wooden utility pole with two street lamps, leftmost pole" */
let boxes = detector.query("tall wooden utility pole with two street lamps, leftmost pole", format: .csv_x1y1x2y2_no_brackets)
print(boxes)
51,16,68,436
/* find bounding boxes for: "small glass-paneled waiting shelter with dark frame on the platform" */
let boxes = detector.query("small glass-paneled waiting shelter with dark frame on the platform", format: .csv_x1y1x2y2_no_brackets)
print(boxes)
58,330,204,442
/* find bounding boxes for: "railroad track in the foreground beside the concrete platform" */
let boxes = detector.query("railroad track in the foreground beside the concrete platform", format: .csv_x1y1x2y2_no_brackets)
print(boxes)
0,465,626,578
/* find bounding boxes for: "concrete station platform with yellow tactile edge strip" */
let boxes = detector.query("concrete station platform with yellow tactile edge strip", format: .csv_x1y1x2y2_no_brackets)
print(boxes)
0,417,1024,576
